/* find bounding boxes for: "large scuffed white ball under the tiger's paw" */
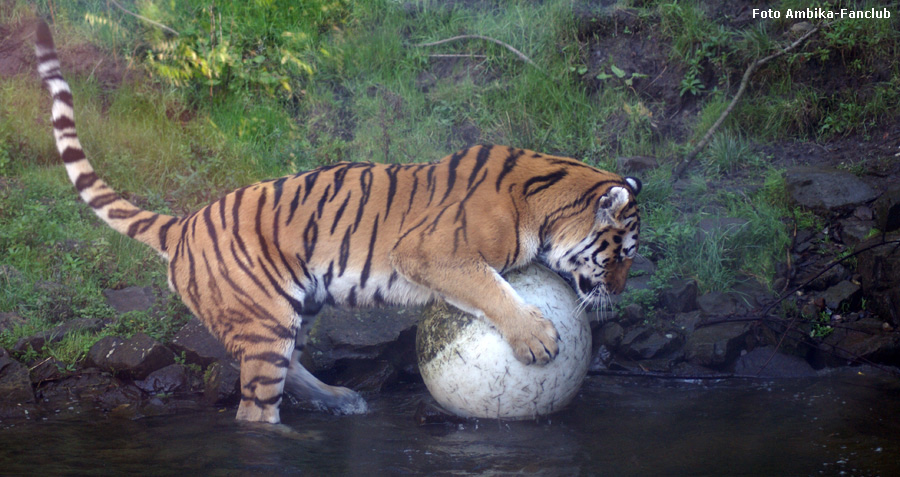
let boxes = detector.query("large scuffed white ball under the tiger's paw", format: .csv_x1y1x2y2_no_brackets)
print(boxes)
416,265,591,419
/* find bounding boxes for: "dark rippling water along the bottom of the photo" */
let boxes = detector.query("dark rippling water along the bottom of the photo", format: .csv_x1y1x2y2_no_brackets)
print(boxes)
0,372,900,476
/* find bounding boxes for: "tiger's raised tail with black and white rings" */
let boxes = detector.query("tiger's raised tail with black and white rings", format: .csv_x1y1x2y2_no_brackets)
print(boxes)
34,20,179,257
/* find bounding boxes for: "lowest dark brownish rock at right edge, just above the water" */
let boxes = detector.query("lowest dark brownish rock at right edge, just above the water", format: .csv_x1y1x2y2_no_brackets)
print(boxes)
821,318,900,366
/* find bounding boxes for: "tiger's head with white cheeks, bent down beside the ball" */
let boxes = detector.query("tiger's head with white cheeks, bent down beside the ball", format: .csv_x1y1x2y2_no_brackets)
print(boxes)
544,177,642,306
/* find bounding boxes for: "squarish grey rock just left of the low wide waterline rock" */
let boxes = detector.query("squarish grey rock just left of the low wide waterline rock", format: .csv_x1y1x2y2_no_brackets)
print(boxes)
684,323,749,368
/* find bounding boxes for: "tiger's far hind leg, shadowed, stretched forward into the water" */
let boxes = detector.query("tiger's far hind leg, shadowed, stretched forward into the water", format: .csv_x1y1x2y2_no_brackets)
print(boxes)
285,316,368,415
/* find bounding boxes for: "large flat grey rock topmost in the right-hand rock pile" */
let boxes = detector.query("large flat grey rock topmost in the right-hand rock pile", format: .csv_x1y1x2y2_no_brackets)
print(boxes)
785,167,878,212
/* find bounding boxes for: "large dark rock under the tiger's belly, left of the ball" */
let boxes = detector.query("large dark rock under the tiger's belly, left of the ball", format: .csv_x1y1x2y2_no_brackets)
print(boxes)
307,307,421,370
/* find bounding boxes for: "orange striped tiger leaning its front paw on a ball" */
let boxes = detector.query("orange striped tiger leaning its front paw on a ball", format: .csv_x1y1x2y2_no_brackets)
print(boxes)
35,21,642,423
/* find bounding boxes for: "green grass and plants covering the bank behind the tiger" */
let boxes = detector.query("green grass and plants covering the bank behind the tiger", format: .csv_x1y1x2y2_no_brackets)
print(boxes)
0,0,900,362
